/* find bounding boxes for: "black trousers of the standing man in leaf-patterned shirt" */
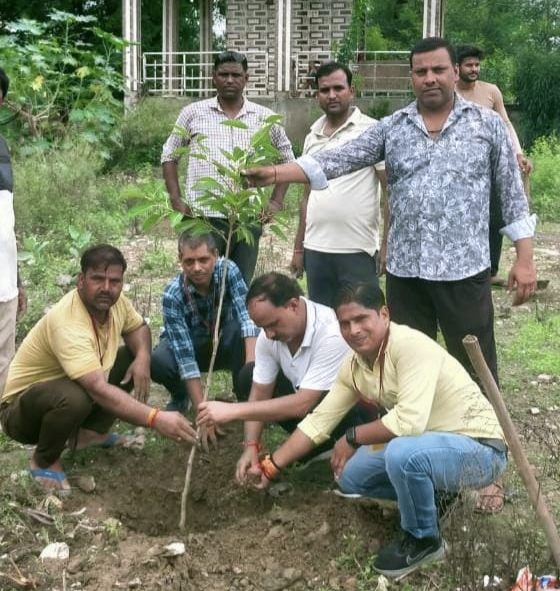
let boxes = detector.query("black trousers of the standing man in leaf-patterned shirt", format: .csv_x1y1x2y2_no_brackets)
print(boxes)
387,269,499,383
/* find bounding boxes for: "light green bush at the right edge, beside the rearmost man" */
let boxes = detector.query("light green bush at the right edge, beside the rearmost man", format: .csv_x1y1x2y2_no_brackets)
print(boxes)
530,134,560,222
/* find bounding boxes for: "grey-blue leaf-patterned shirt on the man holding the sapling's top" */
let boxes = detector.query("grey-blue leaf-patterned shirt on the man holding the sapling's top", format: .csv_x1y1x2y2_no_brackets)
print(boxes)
297,95,536,281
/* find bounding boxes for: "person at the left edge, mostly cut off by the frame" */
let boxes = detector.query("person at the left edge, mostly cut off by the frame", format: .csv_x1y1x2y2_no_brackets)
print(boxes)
0,68,27,395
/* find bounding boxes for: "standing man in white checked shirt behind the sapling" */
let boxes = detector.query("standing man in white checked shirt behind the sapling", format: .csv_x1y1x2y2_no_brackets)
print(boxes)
161,51,294,285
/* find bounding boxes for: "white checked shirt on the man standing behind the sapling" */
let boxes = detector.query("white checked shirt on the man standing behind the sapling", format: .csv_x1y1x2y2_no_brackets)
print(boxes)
161,97,294,217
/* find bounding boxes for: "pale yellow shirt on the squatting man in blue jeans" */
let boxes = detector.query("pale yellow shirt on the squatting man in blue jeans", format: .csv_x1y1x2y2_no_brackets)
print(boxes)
298,322,504,444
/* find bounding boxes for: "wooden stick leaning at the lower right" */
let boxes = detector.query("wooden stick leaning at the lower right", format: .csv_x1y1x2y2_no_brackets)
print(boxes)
463,335,560,568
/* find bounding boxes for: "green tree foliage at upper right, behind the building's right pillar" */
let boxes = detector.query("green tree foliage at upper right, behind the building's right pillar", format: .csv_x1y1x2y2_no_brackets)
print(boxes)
338,0,560,146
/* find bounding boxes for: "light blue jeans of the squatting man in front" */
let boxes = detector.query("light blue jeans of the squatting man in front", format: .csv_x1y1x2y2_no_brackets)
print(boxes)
338,431,507,538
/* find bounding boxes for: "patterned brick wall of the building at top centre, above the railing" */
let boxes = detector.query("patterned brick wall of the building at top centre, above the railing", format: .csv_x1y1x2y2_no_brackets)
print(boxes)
226,0,352,95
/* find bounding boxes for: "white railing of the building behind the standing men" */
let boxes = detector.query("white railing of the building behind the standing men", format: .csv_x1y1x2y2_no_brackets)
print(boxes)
141,51,412,98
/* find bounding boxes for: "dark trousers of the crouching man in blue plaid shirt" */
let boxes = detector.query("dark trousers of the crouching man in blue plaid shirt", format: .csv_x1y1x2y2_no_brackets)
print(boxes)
151,320,245,404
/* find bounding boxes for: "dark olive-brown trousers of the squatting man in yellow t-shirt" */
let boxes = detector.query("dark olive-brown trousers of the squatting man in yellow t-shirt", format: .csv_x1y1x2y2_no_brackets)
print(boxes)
0,346,134,468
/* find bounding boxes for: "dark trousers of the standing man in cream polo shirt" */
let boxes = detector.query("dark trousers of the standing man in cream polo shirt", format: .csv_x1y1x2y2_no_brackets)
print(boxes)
304,248,379,308
